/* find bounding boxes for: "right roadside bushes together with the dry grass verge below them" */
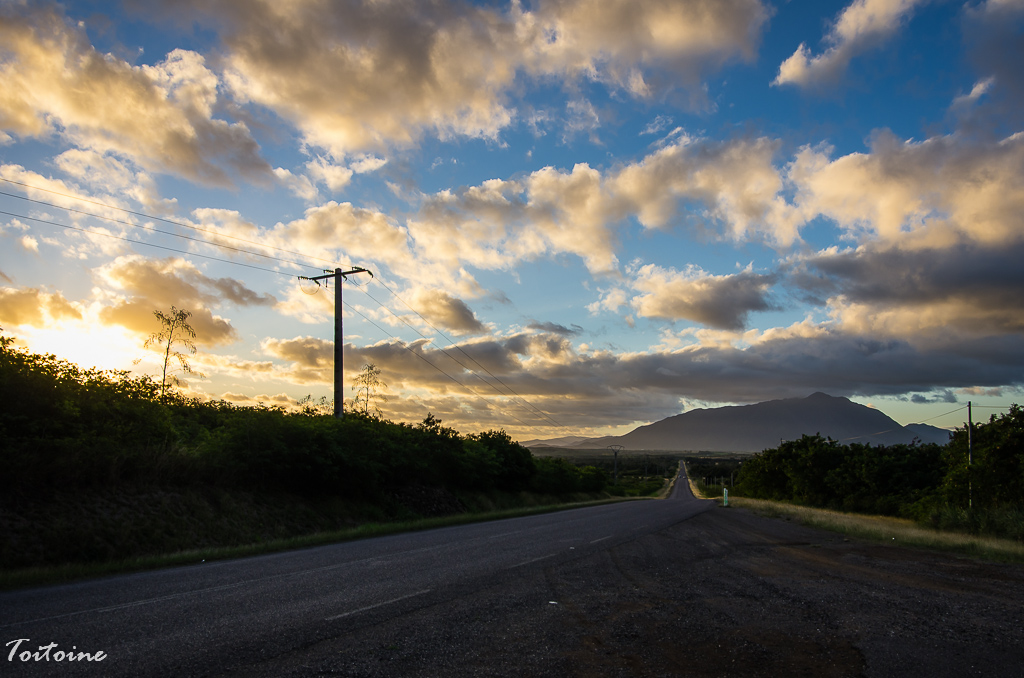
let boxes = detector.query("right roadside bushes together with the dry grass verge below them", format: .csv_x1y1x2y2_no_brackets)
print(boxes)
687,417,1024,562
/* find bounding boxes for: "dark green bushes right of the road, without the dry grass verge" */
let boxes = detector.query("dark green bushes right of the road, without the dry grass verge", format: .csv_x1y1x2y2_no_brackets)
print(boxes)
735,411,1024,540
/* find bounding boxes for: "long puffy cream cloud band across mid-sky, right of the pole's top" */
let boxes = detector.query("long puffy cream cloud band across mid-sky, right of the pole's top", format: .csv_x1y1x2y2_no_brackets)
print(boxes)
408,137,813,273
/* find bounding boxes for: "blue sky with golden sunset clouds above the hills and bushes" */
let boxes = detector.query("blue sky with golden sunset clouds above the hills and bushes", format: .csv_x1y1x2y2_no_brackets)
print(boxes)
0,0,1024,439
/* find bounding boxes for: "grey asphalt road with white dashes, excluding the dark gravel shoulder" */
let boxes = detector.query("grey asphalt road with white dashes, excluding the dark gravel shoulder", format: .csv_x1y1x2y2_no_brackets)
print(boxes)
0,475,712,676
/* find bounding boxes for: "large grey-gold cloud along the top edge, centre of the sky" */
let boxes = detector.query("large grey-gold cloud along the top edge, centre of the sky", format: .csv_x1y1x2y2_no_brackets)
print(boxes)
167,0,770,158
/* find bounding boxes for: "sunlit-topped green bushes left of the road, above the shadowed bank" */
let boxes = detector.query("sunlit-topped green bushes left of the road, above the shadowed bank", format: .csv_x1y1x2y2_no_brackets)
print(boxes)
0,337,605,500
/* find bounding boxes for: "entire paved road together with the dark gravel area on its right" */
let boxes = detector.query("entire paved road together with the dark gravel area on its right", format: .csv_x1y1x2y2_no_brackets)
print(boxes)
0,473,1024,677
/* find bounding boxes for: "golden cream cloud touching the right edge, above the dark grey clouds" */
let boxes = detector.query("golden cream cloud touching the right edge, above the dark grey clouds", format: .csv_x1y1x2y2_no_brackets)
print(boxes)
788,131,1024,249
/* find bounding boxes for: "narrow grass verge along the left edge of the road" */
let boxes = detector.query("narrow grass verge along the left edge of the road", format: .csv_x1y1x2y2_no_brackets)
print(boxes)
0,497,630,591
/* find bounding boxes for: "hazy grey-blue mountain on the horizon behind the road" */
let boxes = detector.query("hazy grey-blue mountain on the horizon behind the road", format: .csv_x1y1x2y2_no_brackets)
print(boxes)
523,393,949,452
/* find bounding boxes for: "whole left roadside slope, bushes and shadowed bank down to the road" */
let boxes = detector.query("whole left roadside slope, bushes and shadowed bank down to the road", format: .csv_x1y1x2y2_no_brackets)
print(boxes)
0,336,625,585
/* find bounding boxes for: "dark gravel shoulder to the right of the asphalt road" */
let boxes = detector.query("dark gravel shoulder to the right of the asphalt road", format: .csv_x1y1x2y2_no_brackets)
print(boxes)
243,508,1024,677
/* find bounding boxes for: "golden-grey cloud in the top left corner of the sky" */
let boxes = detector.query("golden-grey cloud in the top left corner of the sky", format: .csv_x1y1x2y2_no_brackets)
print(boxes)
0,3,270,185
